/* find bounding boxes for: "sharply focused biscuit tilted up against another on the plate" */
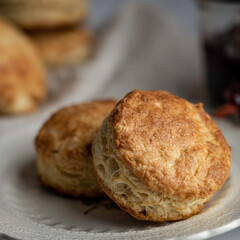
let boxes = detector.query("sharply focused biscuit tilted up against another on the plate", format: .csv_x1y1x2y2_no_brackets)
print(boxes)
92,90,231,222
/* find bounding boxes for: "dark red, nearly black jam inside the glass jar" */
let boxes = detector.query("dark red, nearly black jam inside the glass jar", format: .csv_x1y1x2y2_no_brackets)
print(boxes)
204,24,240,115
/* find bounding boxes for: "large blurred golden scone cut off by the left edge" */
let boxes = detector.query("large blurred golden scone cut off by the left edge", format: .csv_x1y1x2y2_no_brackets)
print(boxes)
0,19,46,114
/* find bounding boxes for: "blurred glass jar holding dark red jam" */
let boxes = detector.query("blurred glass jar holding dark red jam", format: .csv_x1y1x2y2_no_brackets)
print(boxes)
199,0,240,108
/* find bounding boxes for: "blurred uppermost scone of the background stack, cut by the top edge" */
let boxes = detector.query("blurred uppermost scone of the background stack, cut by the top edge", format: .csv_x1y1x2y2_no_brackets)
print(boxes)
0,0,88,29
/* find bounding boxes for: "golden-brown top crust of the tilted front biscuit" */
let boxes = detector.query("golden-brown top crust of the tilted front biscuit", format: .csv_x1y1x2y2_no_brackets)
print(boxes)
108,90,231,199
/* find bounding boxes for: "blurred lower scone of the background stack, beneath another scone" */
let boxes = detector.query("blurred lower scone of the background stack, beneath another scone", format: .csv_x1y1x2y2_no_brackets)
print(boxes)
30,28,93,67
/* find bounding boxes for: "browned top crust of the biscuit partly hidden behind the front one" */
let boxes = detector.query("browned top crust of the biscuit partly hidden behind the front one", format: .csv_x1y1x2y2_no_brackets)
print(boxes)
35,100,117,168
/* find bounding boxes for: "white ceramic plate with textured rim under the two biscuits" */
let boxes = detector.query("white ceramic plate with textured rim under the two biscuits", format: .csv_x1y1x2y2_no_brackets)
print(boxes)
0,120,240,240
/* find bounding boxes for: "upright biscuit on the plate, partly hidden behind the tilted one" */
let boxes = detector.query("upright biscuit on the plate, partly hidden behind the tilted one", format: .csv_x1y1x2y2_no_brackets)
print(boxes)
35,100,116,197
